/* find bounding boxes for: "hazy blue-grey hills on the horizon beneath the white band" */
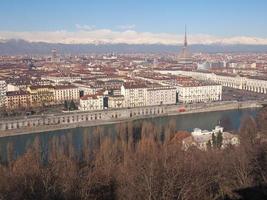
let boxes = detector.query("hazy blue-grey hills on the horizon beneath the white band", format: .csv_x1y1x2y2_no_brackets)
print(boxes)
0,40,267,55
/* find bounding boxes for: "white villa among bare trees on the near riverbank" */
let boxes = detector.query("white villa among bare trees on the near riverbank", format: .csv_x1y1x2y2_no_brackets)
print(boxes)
182,126,239,150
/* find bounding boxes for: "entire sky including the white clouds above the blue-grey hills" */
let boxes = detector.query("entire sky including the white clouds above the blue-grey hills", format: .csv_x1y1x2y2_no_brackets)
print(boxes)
0,0,267,44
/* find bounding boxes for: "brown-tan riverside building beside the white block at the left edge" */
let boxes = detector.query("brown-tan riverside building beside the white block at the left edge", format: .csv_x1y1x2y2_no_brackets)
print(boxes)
6,90,31,110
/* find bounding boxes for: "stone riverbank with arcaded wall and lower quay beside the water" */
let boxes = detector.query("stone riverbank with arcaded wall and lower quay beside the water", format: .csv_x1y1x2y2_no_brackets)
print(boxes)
0,102,261,137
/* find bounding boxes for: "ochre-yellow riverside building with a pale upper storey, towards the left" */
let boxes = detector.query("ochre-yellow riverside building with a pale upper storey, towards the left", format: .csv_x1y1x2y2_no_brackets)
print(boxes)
27,85,55,107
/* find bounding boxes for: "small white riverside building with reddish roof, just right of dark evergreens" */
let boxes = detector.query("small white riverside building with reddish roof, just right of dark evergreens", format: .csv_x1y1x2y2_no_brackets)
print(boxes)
79,94,104,111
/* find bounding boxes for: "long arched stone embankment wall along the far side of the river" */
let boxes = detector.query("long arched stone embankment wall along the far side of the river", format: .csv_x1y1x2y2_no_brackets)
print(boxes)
0,102,260,137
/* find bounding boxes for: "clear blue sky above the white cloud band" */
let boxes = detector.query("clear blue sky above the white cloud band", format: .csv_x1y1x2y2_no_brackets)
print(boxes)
0,0,267,44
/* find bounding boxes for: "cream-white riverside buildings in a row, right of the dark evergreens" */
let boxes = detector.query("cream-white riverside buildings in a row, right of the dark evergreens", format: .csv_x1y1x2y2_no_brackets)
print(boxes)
79,81,222,111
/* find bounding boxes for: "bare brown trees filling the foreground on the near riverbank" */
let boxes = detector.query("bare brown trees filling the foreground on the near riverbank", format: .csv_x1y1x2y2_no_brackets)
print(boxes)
0,109,267,200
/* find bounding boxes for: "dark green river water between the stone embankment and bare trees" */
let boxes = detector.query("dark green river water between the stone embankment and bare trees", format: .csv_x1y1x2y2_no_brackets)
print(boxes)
0,109,259,161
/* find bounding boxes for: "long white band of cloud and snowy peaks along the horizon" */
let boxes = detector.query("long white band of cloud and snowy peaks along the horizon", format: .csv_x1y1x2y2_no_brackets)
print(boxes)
0,28,267,45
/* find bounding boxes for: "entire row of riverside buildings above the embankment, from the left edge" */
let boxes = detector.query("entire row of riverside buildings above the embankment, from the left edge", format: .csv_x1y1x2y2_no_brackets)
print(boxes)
0,77,222,111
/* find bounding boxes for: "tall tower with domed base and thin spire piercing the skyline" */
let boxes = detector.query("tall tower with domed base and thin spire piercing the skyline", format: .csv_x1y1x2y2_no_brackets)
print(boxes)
178,25,193,65
